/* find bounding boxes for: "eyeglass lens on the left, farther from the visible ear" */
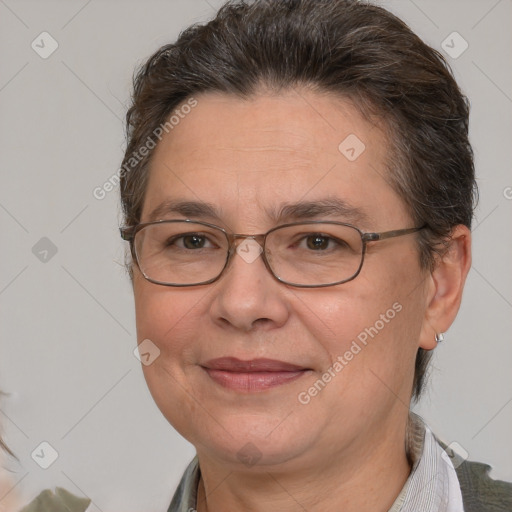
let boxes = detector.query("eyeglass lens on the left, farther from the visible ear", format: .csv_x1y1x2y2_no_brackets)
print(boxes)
134,221,228,286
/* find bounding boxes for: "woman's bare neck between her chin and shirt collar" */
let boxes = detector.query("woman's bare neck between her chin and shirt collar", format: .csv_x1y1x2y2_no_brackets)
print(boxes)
197,420,410,512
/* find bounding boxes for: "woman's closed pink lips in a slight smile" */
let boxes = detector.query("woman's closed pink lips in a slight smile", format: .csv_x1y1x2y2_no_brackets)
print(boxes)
201,357,311,393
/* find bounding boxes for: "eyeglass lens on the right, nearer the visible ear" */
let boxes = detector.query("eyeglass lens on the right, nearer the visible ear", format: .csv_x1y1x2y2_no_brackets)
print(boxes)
266,222,363,286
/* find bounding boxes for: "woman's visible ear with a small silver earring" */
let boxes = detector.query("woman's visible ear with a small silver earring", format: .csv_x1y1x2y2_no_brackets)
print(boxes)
419,225,471,350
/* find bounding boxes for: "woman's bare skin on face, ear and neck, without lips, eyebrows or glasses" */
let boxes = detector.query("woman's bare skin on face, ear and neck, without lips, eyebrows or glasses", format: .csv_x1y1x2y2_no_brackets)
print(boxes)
133,89,470,512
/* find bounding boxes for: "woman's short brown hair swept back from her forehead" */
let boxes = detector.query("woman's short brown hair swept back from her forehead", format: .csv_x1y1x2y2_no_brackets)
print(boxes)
120,0,477,399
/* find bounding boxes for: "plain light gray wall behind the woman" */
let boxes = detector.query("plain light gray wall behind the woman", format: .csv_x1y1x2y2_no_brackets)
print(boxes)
0,0,512,512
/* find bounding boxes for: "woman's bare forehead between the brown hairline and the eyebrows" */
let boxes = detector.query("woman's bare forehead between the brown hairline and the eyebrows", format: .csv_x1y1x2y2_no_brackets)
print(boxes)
143,89,410,227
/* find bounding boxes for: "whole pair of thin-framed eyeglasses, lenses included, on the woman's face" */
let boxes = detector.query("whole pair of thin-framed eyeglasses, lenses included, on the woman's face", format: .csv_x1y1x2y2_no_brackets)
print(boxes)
120,219,426,288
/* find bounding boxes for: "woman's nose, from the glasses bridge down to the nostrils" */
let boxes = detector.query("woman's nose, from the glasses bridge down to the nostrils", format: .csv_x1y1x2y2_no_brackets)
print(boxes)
210,237,289,332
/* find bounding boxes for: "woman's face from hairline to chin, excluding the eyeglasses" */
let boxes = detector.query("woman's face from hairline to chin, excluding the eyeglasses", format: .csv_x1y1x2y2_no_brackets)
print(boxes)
134,90,434,467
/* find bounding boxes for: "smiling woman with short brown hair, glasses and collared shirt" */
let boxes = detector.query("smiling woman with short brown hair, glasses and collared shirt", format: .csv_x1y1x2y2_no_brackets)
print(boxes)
115,0,512,512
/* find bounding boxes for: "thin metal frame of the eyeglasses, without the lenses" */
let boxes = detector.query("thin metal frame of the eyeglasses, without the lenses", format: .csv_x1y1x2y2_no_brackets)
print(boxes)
119,219,427,288
